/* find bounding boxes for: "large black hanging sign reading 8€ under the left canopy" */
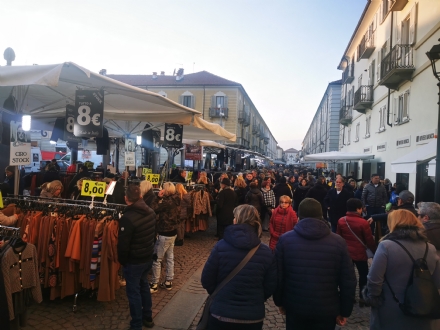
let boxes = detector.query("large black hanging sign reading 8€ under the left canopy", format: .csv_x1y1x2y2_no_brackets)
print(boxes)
75,90,104,138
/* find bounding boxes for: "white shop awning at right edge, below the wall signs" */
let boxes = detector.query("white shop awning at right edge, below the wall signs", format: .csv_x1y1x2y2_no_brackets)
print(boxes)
391,139,437,173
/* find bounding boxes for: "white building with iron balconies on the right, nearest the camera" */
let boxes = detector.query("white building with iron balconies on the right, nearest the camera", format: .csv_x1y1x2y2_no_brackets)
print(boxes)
338,0,440,200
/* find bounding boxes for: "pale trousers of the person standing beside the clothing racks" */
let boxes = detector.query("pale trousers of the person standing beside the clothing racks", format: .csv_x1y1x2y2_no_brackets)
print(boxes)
151,235,176,283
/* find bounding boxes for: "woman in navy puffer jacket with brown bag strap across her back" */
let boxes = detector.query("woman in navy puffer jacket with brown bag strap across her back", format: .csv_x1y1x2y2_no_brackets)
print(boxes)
202,205,276,330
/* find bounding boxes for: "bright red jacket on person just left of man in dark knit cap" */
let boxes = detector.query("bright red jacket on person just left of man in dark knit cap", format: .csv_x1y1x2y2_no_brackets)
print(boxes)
269,206,298,251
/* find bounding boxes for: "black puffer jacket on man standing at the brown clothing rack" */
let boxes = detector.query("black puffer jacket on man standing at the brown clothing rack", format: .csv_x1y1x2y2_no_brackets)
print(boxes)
118,198,156,265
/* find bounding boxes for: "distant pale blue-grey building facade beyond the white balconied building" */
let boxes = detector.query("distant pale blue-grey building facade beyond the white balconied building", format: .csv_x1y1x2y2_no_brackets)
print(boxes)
301,80,341,156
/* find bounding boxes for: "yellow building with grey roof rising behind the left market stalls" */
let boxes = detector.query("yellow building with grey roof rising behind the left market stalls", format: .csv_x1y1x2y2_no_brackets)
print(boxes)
107,69,277,159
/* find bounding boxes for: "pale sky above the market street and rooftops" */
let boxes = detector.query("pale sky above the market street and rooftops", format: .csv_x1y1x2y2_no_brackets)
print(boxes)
0,0,367,149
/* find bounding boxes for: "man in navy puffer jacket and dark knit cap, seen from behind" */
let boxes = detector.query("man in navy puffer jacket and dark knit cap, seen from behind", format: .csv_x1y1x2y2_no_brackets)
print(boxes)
274,198,356,330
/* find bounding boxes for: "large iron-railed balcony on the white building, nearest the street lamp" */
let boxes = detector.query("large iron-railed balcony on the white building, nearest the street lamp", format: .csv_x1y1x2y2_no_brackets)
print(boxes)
379,45,415,89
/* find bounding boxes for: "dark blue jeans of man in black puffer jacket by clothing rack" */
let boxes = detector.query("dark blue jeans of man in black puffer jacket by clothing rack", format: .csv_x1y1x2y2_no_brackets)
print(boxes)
123,261,153,330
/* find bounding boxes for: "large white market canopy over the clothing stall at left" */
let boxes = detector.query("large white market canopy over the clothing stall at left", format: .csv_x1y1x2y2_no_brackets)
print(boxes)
0,62,235,141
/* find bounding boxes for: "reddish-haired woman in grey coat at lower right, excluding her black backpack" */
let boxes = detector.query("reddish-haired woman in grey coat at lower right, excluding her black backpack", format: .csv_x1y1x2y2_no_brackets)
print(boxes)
363,210,440,330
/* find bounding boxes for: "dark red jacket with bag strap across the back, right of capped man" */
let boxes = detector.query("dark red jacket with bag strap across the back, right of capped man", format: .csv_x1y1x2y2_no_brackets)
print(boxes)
336,212,376,261
